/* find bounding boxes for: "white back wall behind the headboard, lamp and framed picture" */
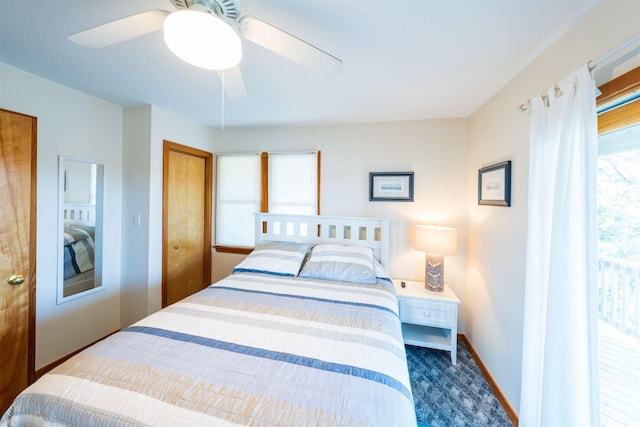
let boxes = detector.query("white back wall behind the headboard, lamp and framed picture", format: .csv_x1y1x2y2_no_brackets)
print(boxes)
213,119,467,326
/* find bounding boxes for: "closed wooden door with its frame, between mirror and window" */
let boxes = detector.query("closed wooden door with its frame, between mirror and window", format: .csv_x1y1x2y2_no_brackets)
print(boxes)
162,141,213,307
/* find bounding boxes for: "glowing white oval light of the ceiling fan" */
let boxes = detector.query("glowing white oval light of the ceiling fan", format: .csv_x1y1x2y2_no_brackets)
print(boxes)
164,7,242,70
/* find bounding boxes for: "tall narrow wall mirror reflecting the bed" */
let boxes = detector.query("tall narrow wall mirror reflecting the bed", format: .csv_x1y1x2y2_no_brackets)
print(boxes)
58,156,104,304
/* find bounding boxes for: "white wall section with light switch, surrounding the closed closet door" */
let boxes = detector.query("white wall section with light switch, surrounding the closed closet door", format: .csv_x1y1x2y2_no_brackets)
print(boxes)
121,106,214,327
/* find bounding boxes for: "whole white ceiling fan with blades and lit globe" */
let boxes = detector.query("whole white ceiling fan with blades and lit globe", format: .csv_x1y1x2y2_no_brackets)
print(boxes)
67,0,342,98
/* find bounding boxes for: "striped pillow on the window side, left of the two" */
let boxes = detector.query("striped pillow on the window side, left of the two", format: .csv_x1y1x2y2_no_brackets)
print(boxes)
233,242,310,276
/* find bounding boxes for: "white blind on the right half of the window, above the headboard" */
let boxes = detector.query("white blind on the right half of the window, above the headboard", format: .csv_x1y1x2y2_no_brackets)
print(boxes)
268,153,318,215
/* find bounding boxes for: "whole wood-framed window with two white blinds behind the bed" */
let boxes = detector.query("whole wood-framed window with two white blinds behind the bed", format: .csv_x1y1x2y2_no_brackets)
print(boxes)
215,151,320,253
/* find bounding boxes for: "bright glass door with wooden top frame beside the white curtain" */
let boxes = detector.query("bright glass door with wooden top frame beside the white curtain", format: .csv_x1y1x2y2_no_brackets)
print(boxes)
597,68,640,426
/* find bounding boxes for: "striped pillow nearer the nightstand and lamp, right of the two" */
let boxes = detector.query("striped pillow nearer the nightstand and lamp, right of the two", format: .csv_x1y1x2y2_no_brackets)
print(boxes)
300,245,376,284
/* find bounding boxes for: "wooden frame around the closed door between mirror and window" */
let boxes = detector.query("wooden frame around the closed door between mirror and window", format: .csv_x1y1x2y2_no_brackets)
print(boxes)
162,140,213,307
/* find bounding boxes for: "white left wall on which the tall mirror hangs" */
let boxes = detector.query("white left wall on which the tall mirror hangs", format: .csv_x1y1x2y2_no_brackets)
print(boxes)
0,63,122,368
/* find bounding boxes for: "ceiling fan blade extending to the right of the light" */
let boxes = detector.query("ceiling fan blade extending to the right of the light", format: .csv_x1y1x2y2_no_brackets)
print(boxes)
239,15,342,75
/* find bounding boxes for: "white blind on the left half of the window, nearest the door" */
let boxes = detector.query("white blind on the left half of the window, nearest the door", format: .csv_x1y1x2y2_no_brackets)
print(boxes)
215,153,260,246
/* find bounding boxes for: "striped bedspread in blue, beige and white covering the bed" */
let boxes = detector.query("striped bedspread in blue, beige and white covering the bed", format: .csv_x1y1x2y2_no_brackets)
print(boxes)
0,273,416,427
